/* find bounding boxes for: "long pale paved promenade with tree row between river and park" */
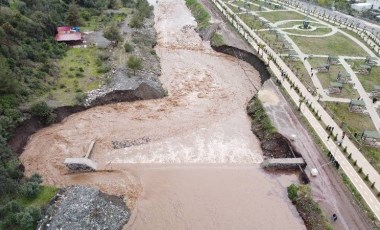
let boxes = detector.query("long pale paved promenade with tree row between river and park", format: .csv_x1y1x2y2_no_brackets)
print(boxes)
212,0,380,219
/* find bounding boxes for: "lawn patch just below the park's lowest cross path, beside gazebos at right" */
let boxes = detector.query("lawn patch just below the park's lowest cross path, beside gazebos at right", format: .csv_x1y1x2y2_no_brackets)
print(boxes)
325,102,376,134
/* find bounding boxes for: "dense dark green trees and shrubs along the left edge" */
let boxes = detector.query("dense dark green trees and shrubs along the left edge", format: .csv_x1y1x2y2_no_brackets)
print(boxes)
0,0,143,229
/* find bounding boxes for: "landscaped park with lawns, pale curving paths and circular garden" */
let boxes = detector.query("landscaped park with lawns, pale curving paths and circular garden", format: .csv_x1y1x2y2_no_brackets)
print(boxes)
225,0,380,172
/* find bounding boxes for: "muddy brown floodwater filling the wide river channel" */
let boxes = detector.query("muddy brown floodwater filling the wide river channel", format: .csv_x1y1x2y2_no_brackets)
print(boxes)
20,0,305,229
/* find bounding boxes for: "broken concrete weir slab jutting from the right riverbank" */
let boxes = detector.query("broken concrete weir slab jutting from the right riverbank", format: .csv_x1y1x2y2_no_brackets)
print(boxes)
261,157,306,169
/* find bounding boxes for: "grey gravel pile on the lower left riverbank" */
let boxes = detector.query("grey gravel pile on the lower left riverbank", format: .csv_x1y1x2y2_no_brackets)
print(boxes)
37,186,130,230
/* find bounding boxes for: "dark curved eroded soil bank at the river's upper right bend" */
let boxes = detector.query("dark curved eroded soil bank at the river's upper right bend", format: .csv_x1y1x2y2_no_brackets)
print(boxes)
212,45,271,84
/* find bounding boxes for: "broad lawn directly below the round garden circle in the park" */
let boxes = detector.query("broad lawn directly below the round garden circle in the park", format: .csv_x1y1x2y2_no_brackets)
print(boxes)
290,33,365,57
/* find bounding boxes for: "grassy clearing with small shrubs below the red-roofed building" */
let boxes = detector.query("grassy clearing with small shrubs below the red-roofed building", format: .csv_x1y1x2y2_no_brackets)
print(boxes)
50,48,102,105
